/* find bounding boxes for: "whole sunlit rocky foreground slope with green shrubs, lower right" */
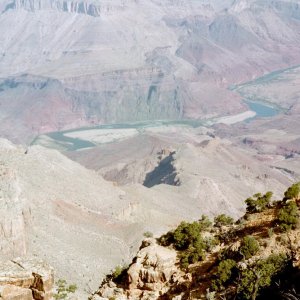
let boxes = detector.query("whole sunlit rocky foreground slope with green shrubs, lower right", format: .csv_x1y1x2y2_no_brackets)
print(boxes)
90,193,300,300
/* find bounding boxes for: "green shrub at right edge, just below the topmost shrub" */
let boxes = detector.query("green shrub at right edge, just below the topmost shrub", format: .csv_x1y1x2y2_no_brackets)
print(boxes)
278,202,299,231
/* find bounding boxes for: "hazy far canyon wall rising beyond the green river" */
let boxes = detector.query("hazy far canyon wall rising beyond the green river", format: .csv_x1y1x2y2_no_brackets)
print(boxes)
0,0,300,141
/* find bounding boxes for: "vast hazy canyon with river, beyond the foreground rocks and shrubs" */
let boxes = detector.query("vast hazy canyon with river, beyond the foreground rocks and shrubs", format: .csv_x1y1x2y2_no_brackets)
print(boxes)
0,0,300,299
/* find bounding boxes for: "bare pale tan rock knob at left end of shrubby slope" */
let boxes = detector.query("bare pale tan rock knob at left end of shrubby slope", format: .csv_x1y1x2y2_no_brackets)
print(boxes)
92,239,183,300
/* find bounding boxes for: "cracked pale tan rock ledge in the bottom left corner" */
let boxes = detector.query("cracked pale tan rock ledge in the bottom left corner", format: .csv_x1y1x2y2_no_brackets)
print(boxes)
0,258,54,300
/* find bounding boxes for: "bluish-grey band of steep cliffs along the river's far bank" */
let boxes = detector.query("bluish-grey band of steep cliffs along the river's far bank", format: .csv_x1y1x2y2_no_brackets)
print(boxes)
0,73,184,142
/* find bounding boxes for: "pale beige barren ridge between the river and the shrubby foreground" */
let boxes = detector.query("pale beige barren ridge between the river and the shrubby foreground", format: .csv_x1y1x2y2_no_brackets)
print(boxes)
0,128,298,297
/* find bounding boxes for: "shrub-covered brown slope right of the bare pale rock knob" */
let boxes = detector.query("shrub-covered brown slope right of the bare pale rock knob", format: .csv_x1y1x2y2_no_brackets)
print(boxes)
100,182,300,300
